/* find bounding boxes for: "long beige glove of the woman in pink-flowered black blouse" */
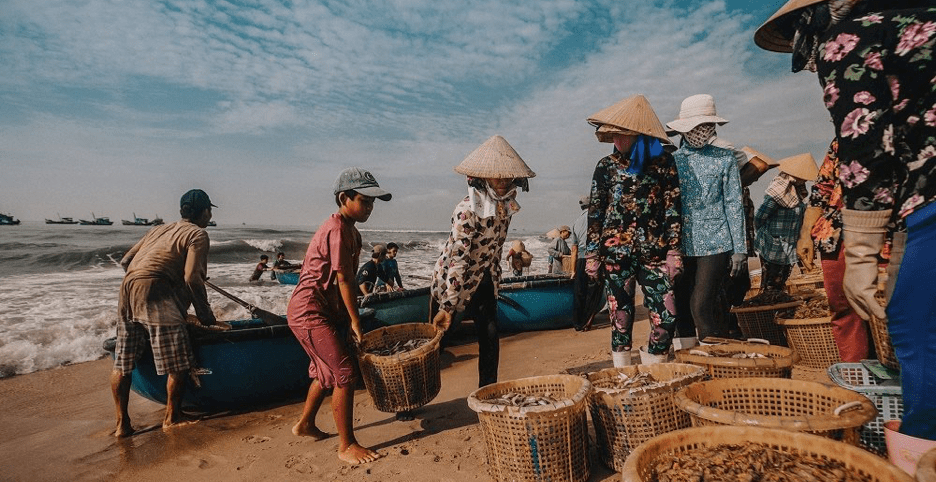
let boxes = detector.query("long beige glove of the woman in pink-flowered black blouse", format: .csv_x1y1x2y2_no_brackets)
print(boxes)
842,209,891,320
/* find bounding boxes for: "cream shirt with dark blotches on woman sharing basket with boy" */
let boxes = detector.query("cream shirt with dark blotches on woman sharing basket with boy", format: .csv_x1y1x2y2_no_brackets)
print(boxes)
430,196,511,313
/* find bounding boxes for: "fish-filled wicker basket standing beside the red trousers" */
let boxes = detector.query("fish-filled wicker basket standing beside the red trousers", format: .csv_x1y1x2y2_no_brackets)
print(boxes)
775,296,842,370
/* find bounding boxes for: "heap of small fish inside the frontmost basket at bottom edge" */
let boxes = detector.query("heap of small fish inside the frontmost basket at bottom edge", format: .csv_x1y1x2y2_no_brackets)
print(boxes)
651,443,874,482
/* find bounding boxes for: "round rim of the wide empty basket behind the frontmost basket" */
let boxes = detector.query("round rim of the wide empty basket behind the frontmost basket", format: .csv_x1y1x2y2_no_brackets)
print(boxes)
673,378,877,432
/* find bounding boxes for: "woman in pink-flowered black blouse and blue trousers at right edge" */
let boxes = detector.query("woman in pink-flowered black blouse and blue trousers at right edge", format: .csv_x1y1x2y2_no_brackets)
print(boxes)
754,0,936,440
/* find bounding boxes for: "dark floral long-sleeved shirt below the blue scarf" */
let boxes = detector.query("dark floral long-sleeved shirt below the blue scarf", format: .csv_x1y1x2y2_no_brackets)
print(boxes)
585,152,681,262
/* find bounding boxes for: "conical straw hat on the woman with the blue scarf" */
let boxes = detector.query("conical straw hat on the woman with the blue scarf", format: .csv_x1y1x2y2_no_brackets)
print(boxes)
587,94,670,144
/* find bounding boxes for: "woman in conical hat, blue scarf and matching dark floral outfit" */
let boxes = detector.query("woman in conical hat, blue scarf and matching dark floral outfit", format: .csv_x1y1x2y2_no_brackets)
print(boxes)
585,95,681,367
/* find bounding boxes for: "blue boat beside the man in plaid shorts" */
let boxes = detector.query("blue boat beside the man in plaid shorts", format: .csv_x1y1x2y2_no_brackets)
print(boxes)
104,319,310,411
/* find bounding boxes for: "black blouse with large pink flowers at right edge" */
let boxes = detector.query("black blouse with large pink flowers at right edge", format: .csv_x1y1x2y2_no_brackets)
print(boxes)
816,8,936,218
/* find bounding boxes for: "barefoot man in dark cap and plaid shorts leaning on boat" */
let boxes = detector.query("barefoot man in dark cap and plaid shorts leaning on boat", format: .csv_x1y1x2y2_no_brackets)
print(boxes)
110,189,226,437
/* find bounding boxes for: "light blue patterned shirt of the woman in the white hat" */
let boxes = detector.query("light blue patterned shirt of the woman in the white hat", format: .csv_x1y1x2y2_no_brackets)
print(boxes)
673,144,748,256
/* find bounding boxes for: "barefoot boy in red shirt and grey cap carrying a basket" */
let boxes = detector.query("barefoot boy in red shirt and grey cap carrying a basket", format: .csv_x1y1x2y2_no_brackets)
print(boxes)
286,167,391,464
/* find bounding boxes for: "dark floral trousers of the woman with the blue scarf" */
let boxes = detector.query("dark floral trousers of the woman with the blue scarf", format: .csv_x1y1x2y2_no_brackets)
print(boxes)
604,255,676,355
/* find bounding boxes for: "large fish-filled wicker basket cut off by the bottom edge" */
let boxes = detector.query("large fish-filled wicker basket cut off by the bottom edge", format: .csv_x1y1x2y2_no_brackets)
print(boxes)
622,427,914,482
